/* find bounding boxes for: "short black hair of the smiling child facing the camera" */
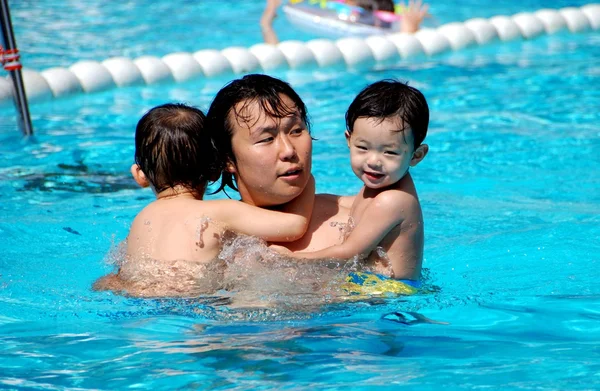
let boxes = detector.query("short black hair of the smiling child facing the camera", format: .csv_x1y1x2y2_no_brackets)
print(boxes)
346,80,429,149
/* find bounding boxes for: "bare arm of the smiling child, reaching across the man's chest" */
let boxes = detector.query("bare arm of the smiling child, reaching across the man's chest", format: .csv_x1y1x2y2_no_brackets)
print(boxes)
291,191,405,259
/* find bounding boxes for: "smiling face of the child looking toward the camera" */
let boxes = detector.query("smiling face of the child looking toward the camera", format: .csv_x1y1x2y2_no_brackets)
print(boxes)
346,117,427,189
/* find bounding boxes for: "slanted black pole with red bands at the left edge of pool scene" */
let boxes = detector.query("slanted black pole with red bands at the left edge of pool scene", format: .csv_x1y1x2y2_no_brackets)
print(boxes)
0,0,33,136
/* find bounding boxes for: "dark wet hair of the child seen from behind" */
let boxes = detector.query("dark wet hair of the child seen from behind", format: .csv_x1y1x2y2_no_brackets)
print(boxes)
135,103,222,198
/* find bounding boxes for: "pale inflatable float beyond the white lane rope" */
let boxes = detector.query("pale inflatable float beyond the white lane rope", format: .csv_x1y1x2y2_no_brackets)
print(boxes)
282,0,400,37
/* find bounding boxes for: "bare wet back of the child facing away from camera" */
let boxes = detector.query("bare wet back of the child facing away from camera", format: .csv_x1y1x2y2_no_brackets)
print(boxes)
94,197,225,297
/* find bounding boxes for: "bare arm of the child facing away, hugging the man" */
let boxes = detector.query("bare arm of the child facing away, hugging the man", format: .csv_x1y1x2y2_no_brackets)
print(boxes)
212,175,315,242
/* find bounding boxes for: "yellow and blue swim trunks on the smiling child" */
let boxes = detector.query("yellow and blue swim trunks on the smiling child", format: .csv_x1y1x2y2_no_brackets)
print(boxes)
342,272,421,295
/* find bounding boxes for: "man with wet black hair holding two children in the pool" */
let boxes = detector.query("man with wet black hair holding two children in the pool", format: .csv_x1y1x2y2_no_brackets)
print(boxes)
208,75,423,280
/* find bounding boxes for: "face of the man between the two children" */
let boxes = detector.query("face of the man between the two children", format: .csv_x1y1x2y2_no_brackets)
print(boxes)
227,95,312,206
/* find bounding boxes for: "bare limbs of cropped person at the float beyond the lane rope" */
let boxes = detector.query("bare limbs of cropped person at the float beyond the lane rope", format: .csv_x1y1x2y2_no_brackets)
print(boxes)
260,0,429,45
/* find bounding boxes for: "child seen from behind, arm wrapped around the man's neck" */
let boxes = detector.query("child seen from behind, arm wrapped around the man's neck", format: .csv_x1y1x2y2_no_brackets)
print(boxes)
95,104,314,296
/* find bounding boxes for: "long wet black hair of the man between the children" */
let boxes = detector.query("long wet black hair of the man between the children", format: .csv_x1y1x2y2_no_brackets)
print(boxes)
208,74,310,192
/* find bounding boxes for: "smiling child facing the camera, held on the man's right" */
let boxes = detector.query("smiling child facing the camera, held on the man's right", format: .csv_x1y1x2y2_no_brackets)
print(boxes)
284,80,429,285
